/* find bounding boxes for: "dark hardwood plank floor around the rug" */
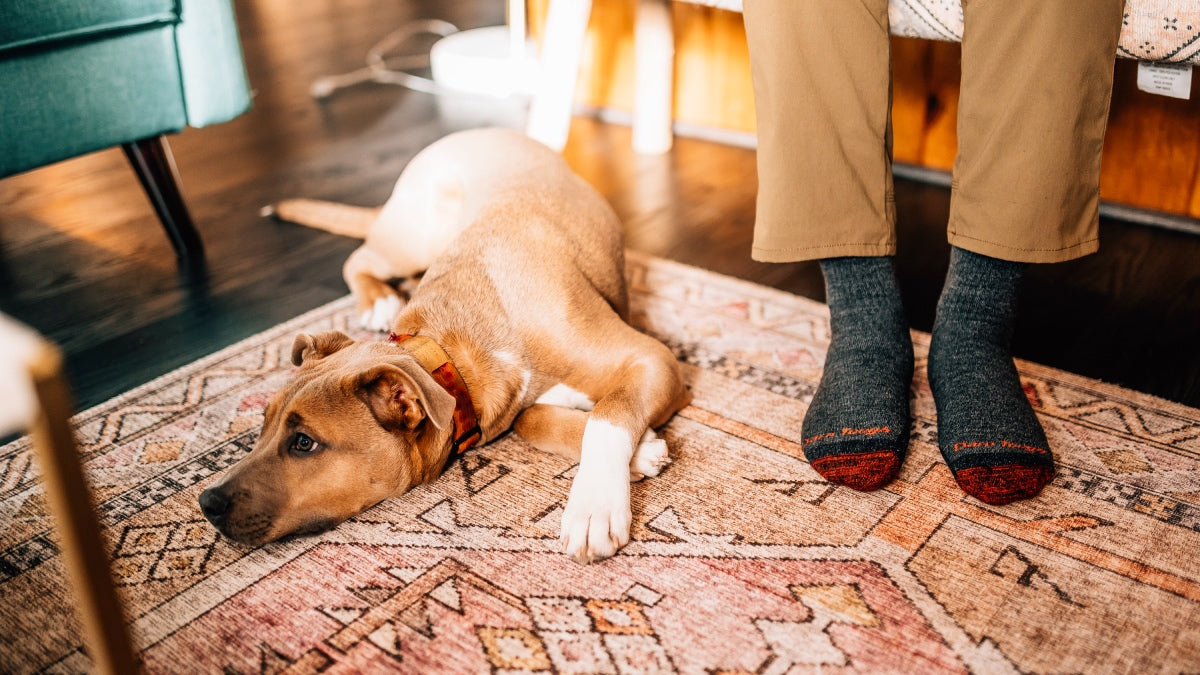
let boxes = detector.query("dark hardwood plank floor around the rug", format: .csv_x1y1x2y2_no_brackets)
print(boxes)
0,0,1200,408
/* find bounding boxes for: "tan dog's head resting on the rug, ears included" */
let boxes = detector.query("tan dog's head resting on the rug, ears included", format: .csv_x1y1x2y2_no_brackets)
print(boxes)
200,330,455,545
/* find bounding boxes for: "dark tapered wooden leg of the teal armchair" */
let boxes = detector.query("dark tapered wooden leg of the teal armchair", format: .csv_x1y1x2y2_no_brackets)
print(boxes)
121,136,204,265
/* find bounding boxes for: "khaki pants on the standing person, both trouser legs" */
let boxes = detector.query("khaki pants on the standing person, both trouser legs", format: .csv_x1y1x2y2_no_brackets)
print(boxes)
744,0,1124,262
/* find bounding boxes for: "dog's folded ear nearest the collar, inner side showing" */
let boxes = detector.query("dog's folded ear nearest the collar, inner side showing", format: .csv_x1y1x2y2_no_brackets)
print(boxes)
354,360,455,431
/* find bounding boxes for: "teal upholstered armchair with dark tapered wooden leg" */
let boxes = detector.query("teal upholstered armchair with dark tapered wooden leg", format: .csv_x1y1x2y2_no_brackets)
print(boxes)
0,0,250,262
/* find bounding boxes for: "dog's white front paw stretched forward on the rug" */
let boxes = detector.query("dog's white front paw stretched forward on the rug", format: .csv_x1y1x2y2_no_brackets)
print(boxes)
559,419,634,565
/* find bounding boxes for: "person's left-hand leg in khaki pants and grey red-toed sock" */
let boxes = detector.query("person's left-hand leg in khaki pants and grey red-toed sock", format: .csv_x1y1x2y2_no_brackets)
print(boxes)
745,0,912,490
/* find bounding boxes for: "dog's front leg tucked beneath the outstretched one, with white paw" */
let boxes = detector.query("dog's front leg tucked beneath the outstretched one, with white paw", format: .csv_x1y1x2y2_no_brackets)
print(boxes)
512,404,671,482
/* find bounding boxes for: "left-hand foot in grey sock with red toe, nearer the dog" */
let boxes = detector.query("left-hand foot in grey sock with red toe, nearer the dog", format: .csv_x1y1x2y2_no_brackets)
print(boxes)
800,257,912,491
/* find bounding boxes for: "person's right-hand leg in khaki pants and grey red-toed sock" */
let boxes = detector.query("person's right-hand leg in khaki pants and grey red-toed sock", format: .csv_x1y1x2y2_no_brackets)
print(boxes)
929,0,1123,504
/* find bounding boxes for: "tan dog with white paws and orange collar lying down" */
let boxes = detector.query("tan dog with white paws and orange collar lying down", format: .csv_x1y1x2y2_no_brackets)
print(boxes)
199,130,690,562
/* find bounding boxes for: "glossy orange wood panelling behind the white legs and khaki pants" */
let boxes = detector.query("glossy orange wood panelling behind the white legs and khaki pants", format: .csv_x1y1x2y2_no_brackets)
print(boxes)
528,0,1200,217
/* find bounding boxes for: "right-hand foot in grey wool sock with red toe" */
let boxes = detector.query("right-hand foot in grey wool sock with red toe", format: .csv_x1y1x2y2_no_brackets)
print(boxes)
929,247,1054,504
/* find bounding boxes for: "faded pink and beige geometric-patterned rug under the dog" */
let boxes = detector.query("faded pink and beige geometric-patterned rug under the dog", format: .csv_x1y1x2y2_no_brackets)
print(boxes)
0,249,1200,674
